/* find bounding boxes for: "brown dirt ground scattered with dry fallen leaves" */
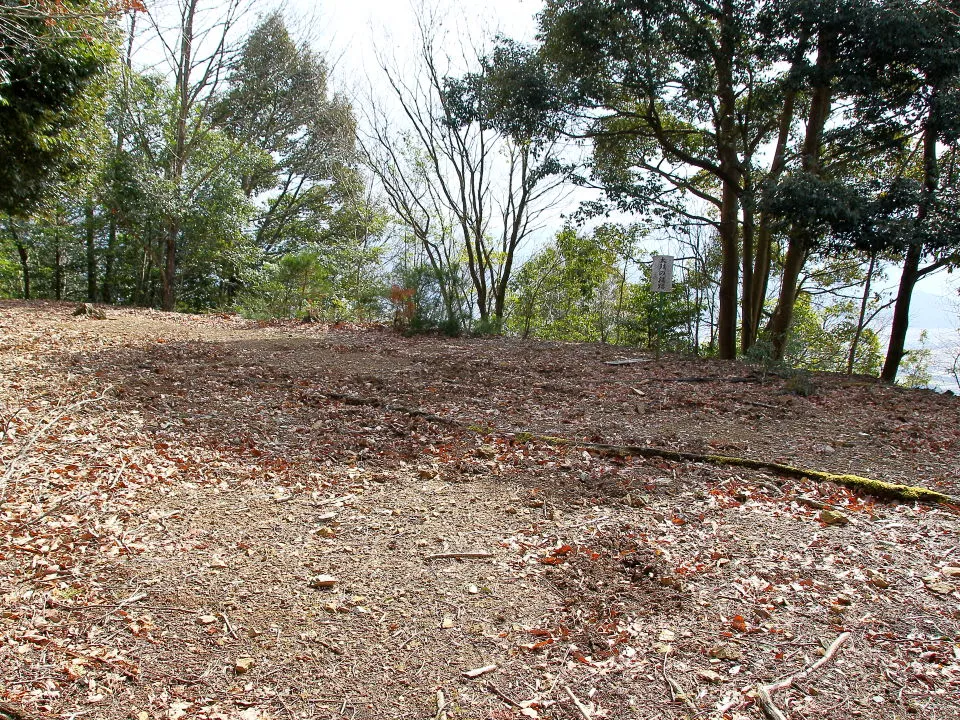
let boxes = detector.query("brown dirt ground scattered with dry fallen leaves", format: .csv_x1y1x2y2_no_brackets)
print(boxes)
0,302,960,720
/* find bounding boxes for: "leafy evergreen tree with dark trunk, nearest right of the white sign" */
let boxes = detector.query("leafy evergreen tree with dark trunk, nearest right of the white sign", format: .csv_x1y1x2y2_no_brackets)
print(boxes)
468,0,770,358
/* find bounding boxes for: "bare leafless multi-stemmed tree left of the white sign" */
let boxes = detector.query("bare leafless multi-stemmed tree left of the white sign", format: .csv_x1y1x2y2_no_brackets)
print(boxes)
365,16,560,326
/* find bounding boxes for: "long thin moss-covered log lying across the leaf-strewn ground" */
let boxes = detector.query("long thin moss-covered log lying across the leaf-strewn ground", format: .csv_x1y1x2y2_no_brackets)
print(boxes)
320,392,960,507
